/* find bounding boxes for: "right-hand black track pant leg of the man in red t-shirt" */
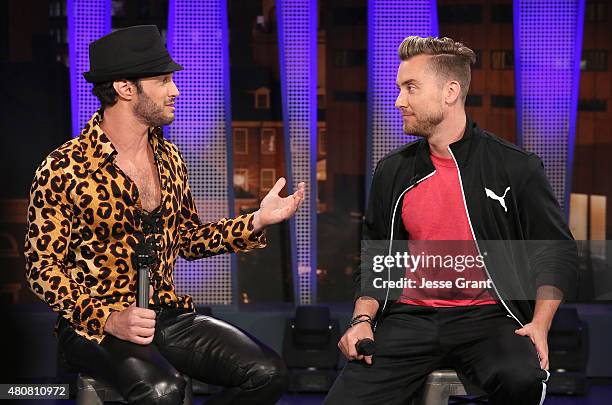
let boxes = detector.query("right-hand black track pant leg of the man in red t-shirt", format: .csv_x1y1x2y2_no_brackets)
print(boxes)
446,306,548,405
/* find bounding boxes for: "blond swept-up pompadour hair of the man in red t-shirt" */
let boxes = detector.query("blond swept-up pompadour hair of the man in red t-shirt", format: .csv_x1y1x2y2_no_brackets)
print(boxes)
397,36,476,102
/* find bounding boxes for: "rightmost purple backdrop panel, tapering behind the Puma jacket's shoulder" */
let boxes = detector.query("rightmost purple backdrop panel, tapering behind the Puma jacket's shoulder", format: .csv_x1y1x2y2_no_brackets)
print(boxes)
514,0,585,216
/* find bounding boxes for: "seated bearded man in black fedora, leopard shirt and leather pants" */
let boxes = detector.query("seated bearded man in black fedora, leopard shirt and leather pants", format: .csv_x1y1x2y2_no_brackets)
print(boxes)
24,25,304,404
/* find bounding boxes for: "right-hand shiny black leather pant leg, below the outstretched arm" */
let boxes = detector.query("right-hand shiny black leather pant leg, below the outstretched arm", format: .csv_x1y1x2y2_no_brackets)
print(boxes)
155,309,289,405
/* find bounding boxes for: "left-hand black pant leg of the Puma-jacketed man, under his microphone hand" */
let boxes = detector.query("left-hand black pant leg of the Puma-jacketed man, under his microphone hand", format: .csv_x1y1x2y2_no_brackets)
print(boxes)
324,304,445,405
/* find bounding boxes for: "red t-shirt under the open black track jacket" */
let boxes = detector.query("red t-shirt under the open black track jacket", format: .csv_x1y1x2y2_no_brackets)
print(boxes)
399,155,496,307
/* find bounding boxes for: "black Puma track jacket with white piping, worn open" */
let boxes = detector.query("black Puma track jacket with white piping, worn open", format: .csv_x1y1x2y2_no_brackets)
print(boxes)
353,117,578,325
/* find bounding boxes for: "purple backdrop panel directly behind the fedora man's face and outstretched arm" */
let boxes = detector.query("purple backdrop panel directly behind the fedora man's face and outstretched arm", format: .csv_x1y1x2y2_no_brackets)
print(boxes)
167,0,236,305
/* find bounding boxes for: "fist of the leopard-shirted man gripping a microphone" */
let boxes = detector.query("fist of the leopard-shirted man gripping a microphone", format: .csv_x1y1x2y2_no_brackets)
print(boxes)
104,287,155,345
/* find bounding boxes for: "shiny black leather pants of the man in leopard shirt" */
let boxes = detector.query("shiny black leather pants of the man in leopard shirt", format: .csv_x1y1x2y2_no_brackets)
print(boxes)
58,308,288,405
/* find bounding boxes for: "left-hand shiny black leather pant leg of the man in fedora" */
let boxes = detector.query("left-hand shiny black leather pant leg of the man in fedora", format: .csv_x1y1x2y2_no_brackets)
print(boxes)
58,319,185,405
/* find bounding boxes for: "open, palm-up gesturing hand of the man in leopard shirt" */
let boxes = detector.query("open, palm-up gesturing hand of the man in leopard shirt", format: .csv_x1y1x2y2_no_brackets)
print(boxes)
253,177,306,232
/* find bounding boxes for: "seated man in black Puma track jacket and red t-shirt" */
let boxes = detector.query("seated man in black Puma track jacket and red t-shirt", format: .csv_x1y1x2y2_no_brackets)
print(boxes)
325,37,578,404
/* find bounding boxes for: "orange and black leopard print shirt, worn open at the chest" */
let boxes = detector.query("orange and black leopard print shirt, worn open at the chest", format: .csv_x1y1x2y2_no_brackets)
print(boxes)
24,112,266,343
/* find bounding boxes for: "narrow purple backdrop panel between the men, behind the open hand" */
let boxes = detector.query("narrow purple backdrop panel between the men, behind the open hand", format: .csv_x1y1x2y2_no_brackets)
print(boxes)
276,0,317,304
